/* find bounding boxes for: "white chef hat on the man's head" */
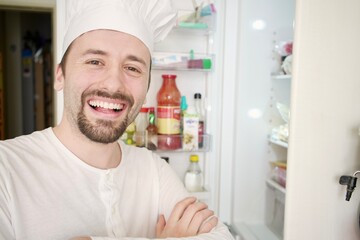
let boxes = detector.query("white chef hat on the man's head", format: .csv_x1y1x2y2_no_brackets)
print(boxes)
61,0,176,58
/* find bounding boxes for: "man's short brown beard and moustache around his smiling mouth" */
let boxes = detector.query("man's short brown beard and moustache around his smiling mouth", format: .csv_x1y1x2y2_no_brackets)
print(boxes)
77,91,134,144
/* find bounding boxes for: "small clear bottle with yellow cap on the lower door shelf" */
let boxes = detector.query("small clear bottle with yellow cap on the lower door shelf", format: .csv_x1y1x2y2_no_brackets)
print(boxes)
184,155,203,192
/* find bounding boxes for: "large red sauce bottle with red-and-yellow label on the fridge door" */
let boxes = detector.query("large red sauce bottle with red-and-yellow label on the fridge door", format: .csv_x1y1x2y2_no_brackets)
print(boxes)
157,74,181,150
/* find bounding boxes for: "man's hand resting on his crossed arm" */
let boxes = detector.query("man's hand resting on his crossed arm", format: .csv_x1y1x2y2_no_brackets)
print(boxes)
156,197,218,238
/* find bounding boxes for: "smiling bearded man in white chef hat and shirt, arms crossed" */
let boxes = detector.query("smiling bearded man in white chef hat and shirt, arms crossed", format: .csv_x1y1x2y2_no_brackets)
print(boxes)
0,0,232,240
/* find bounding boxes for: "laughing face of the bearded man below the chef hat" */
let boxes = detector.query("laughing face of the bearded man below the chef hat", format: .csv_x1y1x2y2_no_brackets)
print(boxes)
55,30,150,143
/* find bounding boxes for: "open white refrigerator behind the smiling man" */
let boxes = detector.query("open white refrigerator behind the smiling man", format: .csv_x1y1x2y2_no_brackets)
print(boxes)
56,0,360,240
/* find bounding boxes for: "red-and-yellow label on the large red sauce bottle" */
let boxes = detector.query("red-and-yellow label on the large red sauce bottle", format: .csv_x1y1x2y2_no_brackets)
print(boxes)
157,106,180,134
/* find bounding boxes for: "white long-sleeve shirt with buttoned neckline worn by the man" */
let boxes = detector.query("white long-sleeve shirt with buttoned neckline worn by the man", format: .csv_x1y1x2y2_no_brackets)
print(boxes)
0,128,232,240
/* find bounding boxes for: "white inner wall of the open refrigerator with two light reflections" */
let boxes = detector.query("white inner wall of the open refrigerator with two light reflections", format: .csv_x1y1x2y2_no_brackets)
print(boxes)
228,0,295,240
